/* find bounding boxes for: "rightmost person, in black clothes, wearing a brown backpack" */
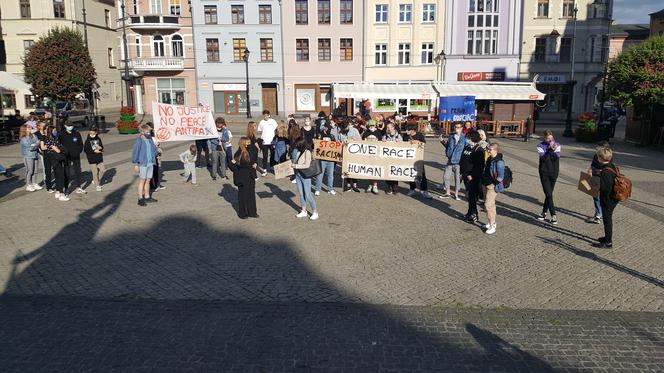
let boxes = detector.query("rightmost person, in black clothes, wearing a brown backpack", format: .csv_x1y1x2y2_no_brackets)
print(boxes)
595,146,618,249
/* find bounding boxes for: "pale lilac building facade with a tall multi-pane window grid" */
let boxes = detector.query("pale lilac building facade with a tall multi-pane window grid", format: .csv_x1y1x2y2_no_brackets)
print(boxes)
443,0,530,81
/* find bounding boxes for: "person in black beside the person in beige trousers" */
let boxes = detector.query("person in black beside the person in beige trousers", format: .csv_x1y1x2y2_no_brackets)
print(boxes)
460,131,484,223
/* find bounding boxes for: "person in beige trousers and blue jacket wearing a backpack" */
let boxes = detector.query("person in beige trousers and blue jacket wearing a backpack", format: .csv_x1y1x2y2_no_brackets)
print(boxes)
482,142,505,234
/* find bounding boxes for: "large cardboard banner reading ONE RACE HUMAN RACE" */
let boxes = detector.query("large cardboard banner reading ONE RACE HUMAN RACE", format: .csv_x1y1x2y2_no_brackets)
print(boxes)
341,141,424,181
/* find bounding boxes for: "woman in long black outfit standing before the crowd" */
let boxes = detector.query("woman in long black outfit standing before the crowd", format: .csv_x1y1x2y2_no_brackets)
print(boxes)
231,137,258,219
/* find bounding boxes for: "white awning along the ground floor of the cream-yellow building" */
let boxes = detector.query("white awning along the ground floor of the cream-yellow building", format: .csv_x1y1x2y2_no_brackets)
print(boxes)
332,83,438,100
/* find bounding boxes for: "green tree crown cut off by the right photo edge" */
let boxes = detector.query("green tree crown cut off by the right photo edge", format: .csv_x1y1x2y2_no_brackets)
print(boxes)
607,37,664,106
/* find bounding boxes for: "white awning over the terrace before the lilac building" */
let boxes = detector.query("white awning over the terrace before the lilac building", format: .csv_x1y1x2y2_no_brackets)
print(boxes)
433,83,545,101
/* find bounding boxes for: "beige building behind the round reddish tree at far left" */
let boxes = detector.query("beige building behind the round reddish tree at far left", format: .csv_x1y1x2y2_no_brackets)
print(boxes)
0,0,122,114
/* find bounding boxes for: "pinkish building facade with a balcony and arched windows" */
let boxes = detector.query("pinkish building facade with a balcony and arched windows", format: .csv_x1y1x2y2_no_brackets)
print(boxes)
116,0,198,114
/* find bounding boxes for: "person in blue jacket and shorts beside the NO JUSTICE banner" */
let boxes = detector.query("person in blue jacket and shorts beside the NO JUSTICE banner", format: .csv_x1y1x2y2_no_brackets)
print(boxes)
131,124,157,206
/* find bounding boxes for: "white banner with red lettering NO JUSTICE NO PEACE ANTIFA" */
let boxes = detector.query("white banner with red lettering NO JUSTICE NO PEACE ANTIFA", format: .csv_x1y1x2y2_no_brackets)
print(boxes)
152,102,219,141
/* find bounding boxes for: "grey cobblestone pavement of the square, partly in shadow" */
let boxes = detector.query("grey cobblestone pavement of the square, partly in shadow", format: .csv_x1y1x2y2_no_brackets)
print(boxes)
0,124,664,371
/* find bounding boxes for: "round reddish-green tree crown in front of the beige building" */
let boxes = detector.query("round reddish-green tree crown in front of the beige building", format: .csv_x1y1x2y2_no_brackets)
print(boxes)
23,27,97,100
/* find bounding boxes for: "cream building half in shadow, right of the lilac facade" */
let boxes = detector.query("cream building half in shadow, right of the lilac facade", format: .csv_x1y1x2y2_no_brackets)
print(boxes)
520,0,613,120
